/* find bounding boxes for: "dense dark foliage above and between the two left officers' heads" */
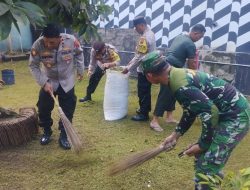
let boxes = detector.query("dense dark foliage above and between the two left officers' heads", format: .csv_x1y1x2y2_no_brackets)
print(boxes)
29,0,111,42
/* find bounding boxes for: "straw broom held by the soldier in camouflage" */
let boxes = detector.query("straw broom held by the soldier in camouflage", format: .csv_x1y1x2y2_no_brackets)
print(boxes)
109,143,175,176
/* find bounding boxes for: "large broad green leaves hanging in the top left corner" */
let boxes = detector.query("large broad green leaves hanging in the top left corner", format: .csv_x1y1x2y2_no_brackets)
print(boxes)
0,0,45,40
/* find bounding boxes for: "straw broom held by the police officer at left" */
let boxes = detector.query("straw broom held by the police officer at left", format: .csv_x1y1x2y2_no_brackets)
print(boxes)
51,93,82,153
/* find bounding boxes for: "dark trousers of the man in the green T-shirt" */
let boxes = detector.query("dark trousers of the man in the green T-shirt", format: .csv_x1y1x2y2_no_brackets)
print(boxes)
154,84,176,117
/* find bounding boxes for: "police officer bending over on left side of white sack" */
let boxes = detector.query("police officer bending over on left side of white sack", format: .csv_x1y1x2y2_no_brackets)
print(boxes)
79,42,120,102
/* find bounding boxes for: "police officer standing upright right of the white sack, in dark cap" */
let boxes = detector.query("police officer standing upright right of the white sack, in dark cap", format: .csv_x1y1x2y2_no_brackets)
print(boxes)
122,16,156,121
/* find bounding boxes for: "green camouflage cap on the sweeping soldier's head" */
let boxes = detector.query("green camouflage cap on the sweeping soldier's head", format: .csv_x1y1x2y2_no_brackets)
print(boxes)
141,51,168,73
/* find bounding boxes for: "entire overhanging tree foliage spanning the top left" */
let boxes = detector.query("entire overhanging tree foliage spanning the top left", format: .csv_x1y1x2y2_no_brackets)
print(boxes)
0,0,111,41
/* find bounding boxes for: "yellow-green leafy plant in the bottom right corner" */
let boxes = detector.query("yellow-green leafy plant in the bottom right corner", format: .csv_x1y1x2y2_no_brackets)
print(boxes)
198,167,250,190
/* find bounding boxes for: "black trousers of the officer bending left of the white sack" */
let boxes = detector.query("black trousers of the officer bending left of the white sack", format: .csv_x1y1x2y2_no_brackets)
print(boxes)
87,66,105,97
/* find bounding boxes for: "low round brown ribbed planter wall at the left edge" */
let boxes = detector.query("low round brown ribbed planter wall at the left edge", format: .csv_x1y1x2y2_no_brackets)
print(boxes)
0,108,38,149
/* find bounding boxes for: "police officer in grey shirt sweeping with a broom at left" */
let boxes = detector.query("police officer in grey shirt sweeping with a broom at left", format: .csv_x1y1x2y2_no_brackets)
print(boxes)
29,24,84,149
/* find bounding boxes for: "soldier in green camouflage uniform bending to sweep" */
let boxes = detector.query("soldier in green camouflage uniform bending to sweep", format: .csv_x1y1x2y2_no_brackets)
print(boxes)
142,52,250,189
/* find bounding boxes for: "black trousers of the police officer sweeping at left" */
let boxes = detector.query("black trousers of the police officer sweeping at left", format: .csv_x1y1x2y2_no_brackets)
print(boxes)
37,86,76,130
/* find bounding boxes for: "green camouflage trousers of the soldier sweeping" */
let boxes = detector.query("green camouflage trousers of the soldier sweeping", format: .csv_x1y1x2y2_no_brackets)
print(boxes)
195,109,250,189
